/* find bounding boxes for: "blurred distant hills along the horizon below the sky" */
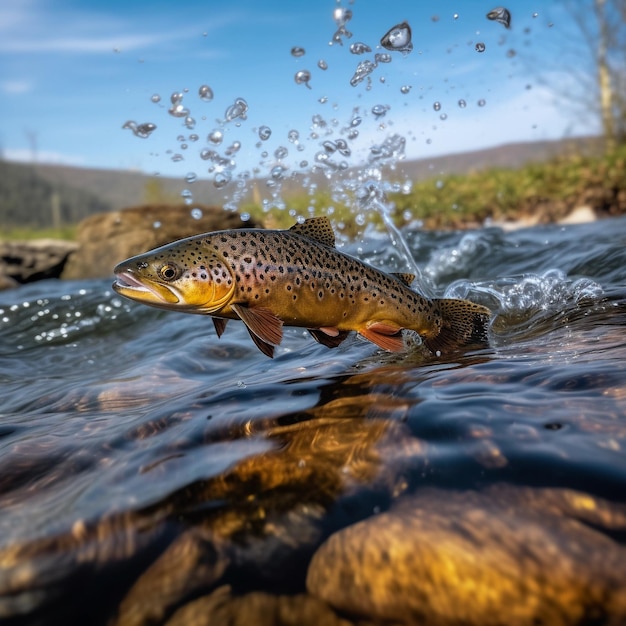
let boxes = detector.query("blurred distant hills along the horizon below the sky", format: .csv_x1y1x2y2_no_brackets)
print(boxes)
0,137,601,236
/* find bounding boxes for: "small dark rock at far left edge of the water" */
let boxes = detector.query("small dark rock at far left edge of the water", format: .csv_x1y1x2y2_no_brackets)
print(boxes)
0,239,78,289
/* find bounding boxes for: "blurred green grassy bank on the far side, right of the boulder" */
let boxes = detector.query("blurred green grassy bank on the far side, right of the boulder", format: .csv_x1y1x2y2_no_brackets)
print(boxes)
242,145,626,232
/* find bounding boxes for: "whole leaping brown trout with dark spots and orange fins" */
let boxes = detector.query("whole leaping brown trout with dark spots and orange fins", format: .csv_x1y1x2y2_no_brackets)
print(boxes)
113,217,490,357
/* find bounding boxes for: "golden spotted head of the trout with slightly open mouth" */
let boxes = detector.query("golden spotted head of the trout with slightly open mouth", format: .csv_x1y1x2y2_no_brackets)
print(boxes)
113,235,235,314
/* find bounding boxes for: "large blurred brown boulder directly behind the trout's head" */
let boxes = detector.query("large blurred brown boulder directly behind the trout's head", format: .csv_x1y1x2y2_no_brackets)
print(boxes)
62,205,258,279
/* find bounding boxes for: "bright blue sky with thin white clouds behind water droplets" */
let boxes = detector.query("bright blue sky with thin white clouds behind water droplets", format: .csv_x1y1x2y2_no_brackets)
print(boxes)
0,0,598,176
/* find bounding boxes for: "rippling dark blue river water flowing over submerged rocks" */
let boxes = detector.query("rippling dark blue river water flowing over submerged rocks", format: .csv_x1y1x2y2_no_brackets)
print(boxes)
0,218,626,624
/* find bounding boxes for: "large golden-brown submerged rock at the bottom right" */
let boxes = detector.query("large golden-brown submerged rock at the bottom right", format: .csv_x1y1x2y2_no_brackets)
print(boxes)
307,486,626,626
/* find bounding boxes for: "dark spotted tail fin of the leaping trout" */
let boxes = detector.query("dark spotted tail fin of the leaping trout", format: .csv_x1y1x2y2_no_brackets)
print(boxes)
422,299,491,352
